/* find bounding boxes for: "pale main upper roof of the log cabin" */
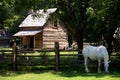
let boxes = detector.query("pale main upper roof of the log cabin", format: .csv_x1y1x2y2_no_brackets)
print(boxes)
19,8,57,27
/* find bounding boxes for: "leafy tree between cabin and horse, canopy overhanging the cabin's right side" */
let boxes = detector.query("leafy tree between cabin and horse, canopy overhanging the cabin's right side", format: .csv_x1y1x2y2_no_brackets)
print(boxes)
57,0,88,58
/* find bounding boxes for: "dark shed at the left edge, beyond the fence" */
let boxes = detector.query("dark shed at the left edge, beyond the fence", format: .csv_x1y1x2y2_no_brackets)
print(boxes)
0,29,12,47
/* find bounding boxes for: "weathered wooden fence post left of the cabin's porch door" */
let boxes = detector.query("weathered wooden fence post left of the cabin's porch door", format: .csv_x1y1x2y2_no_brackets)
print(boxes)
12,41,17,71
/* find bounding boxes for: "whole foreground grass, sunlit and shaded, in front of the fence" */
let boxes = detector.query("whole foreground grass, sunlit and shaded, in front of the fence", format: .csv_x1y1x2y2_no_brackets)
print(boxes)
0,48,120,80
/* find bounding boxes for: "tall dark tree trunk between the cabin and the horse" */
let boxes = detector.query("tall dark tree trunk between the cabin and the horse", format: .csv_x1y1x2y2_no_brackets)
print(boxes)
76,0,89,60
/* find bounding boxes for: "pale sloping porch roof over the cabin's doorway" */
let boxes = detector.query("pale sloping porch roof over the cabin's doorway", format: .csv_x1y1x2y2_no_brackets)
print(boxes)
13,30,42,37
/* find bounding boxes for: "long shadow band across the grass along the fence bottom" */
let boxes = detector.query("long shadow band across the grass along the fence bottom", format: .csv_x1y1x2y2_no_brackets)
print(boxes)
0,65,120,78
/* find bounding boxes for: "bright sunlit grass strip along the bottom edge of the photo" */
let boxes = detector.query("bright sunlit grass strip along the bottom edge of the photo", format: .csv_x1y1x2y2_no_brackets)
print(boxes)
0,72,119,80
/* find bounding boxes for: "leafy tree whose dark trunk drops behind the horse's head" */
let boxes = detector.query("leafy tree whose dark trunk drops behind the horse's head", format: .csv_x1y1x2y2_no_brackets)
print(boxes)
84,0,120,55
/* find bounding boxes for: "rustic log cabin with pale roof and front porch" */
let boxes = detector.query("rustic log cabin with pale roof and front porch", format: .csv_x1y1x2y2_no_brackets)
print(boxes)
13,8,67,49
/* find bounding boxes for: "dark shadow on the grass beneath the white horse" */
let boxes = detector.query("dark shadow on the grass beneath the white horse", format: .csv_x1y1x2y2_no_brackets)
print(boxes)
51,66,120,78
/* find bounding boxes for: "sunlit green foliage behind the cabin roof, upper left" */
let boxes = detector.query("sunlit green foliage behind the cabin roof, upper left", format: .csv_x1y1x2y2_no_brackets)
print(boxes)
0,0,55,34
